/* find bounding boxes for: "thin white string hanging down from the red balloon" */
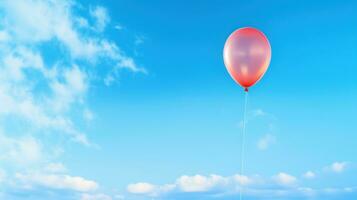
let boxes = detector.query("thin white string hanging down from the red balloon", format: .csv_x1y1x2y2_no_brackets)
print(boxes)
239,91,248,200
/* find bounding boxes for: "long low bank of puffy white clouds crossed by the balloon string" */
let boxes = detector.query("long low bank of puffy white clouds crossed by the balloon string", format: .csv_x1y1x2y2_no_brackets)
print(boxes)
127,172,357,199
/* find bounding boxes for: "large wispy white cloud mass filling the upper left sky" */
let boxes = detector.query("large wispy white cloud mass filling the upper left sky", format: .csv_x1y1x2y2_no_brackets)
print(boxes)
0,0,145,148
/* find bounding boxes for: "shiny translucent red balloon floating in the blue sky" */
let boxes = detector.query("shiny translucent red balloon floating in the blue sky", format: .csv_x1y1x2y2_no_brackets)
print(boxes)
223,27,271,91
